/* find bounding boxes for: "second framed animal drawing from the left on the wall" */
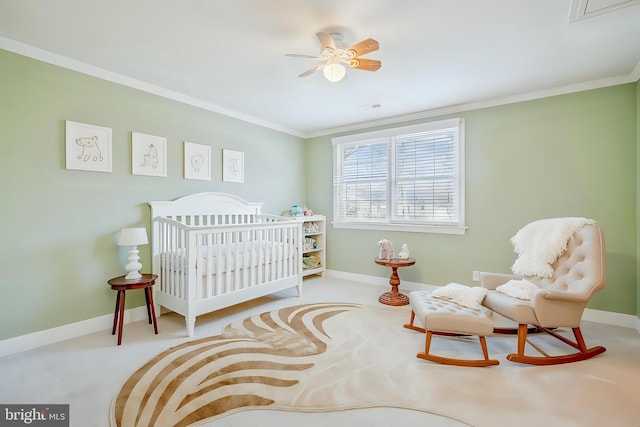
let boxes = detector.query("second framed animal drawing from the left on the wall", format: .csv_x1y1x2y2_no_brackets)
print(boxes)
131,132,167,176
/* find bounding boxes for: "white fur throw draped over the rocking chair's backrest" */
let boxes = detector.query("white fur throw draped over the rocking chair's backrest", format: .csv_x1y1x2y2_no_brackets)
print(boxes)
511,217,595,277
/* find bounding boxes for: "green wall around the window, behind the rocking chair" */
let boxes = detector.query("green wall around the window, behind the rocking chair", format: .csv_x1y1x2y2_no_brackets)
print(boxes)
305,84,639,314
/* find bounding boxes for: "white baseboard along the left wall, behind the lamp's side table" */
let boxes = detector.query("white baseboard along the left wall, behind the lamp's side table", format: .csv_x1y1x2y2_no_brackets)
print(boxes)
0,306,148,357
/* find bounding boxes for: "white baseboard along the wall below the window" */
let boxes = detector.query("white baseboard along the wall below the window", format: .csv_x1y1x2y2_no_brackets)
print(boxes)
327,270,640,334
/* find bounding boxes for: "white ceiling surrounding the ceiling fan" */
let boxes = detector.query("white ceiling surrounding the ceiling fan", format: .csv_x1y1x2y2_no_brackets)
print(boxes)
0,0,640,137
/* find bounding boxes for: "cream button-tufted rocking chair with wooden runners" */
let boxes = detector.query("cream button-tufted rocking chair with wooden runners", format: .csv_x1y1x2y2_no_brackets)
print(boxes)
480,224,606,365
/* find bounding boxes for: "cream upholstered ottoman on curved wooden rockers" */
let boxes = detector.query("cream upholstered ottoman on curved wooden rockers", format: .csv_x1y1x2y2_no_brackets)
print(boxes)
404,291,500,366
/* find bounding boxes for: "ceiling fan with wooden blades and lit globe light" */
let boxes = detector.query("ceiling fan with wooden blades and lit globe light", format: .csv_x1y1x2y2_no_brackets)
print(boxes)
286,33,382,82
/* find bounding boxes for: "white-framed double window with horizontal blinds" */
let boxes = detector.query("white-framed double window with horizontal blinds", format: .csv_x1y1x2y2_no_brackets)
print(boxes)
333,119,465,234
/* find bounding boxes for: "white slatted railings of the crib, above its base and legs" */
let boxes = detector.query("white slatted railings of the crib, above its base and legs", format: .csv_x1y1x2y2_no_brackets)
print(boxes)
152,215,302,305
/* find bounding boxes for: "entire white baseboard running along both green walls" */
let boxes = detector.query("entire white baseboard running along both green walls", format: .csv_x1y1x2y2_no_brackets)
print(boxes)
0,270,640,357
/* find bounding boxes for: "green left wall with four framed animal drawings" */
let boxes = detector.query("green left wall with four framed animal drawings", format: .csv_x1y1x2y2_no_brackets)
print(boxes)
0,50,304,340
